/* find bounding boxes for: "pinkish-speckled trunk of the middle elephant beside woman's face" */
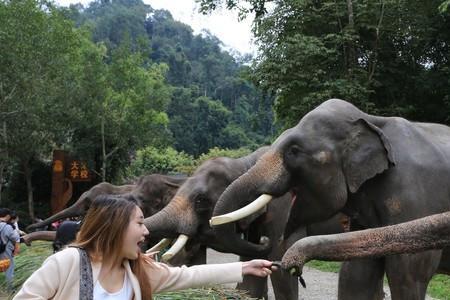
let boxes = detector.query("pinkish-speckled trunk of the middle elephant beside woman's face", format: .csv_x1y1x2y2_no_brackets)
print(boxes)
144,196,198,237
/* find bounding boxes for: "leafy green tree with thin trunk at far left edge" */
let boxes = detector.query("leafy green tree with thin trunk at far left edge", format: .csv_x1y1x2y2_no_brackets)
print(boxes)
0,0,89,218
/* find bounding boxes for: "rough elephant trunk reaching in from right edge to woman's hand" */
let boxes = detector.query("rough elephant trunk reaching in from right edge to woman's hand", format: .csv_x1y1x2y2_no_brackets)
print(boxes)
282,212,450,274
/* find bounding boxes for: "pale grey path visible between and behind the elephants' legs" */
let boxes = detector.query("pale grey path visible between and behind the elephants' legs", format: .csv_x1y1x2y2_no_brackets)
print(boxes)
207,249,433,300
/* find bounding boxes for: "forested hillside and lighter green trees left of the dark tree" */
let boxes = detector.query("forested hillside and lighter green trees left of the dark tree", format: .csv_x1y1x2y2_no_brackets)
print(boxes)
0,0,274,220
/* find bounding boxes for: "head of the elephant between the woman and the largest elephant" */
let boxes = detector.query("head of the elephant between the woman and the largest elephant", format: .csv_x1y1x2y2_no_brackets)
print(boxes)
144,147,267,259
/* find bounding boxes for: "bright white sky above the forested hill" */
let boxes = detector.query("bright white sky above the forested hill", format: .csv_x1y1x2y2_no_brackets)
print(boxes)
55,0,256,54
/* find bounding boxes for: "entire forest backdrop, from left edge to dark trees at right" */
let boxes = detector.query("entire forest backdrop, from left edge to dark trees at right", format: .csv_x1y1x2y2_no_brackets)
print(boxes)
0,0,450,221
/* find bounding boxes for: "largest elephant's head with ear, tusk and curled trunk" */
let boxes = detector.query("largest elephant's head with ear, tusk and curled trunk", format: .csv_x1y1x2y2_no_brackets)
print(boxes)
211,99,394,251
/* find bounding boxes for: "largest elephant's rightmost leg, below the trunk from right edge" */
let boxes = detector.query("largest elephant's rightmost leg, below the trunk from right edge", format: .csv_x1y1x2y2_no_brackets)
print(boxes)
385,250,442,300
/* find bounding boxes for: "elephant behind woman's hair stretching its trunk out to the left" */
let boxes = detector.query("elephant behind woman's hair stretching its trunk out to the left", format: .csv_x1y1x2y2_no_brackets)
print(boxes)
27,174,186,231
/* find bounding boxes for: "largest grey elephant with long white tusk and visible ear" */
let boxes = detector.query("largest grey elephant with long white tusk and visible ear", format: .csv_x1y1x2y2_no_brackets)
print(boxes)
211,99,450,299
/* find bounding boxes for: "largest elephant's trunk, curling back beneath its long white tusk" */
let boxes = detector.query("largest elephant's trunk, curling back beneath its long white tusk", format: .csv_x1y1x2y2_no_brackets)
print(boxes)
213,152,288,256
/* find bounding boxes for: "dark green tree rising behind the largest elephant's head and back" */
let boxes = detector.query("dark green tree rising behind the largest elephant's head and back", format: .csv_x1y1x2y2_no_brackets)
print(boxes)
200,0,450,127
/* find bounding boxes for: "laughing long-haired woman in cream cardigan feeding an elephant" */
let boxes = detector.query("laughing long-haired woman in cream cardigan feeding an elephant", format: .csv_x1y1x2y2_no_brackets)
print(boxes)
14,195,272,300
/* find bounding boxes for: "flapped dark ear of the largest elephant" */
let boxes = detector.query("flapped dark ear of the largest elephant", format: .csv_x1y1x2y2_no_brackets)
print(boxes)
343,119,395,193
